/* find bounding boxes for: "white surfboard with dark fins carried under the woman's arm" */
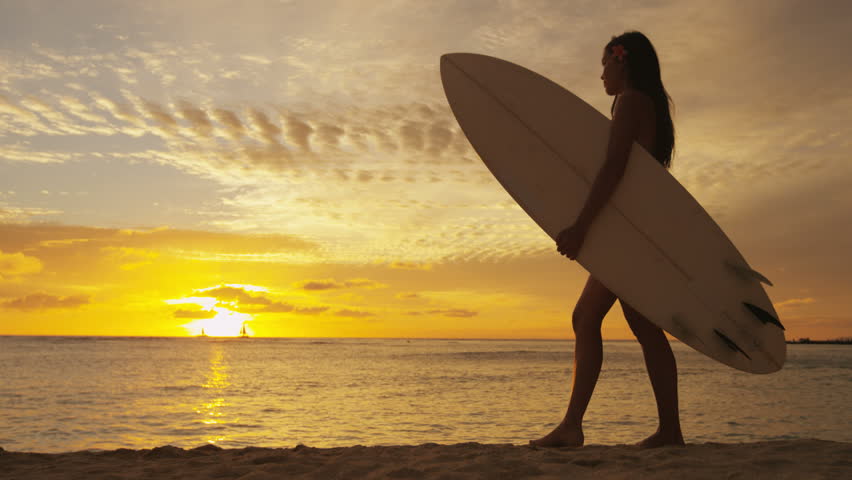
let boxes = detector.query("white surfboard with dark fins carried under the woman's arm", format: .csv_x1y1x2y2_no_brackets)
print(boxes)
440,53,786,373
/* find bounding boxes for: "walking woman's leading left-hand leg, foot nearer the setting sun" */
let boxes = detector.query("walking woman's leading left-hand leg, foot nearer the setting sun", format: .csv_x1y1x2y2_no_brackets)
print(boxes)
530,276,615,447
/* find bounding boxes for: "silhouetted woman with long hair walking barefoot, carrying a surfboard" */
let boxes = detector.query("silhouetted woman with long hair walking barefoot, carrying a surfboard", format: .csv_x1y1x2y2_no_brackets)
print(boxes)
530,31,683,447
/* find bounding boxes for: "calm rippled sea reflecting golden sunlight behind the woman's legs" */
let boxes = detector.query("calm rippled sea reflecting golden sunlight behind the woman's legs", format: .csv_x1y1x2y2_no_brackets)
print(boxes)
0,337,852,452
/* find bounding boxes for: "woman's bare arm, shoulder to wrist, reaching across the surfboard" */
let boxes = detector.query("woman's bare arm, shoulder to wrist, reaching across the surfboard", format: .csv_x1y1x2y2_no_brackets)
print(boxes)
575,92,643,232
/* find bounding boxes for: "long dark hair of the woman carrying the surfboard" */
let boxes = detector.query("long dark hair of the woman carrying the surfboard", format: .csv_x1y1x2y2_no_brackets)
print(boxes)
604,31,674,168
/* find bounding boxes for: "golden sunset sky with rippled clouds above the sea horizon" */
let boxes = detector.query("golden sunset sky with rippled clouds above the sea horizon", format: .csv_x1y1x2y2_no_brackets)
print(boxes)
0,0,852,339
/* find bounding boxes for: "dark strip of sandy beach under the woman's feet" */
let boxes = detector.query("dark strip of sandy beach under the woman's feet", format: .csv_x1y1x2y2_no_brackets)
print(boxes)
0,440,852,480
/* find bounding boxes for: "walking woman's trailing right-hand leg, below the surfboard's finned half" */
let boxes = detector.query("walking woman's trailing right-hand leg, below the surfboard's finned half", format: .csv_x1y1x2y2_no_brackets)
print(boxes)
619,299,683,447
